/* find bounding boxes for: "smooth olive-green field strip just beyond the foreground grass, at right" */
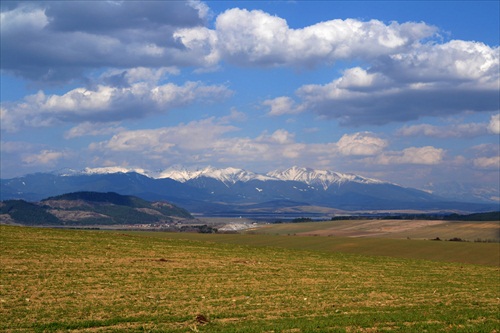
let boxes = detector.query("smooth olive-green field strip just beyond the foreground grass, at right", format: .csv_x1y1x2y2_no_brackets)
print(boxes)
144,232,500,267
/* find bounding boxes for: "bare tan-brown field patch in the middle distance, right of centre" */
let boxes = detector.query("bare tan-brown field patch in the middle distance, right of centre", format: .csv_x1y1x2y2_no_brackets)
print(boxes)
297,220,446,237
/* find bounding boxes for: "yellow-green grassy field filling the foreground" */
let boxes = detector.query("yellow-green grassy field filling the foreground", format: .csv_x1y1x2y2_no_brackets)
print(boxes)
0,226,500,332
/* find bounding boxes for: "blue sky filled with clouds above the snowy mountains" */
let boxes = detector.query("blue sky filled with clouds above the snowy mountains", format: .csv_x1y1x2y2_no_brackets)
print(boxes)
0,1,500,200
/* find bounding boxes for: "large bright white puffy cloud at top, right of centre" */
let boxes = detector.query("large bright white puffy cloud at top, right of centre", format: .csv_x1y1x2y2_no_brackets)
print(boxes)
174,8,436,67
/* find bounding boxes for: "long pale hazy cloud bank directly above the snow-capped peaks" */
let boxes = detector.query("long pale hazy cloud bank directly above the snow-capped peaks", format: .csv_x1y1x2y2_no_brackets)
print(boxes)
89,117,398,168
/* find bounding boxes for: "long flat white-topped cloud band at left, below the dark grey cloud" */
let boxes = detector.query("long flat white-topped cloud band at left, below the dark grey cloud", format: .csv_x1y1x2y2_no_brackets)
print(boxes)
1,81,231,131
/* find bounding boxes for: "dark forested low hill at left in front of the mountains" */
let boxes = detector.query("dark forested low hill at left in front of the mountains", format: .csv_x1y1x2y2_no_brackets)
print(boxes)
0,192,193,226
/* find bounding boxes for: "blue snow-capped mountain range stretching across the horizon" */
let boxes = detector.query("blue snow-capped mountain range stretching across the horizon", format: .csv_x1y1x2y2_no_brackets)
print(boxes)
0,167,498,216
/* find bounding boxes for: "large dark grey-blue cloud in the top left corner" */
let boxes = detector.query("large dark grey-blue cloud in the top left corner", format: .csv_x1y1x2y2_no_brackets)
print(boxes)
0,1,208,82
